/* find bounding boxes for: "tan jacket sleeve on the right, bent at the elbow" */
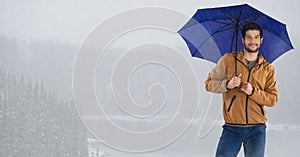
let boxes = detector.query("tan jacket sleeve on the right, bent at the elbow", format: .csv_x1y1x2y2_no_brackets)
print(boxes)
249,67,278,107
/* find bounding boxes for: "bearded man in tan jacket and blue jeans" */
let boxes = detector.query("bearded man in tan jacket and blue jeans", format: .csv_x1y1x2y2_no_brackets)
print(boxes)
205,23,278,157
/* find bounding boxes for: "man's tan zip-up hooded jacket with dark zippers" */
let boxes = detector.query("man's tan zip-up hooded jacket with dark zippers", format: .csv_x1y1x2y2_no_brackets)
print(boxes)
205,52,278,125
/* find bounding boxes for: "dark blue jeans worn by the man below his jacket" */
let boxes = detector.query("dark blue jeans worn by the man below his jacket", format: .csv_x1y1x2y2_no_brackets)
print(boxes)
216,124,266,157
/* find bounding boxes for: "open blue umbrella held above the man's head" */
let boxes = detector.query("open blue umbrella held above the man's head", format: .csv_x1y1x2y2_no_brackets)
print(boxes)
178,4,293,63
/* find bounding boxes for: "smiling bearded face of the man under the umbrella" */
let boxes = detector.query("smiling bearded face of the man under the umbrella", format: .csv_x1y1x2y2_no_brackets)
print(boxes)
242,30,263,53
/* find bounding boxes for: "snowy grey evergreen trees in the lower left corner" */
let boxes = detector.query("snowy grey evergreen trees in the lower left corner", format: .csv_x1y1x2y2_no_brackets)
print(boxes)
0,70,88,157
